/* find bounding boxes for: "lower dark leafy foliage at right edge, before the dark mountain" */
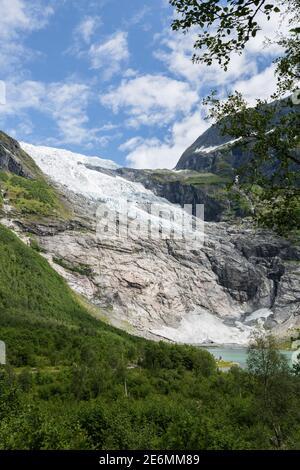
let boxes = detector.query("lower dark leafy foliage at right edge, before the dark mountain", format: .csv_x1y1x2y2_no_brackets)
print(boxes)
205,92,300,235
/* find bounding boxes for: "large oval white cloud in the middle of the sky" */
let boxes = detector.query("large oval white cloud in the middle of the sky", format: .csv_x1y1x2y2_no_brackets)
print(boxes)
100,75,199,127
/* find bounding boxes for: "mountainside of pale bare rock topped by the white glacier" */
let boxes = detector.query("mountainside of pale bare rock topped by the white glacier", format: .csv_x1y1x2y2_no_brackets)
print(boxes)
0,133,300,344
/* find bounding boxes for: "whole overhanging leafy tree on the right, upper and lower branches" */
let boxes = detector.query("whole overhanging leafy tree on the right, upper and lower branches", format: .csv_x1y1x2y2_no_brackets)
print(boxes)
170,0,300,234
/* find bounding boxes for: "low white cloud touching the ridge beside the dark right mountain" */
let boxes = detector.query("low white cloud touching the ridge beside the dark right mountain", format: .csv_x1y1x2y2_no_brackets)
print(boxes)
120,109,208,168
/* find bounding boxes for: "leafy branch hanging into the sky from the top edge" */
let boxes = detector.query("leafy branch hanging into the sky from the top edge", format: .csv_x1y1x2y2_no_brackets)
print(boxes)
170,0,297,69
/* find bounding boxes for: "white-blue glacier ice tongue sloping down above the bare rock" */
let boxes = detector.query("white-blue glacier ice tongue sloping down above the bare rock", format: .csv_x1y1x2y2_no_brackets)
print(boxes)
20,142,203,241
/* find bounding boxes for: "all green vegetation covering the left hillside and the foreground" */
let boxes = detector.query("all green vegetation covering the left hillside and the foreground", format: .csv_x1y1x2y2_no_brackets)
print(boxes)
0,225,300,449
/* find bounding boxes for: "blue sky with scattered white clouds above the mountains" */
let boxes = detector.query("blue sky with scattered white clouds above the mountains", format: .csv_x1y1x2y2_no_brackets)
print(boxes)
0,0,285,168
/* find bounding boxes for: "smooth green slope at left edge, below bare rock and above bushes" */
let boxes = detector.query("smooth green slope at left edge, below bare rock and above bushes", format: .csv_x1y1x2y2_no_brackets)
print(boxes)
0,226,144,366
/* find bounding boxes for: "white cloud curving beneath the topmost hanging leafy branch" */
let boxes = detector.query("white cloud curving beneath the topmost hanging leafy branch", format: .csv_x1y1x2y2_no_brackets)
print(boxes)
153,2,291,90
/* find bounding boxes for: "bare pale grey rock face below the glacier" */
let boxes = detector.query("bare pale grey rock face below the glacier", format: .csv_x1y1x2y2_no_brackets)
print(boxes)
12,188,300,344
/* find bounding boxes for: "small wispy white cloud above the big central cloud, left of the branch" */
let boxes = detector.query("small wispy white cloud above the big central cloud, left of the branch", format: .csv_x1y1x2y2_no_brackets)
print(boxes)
88,31,129,79
